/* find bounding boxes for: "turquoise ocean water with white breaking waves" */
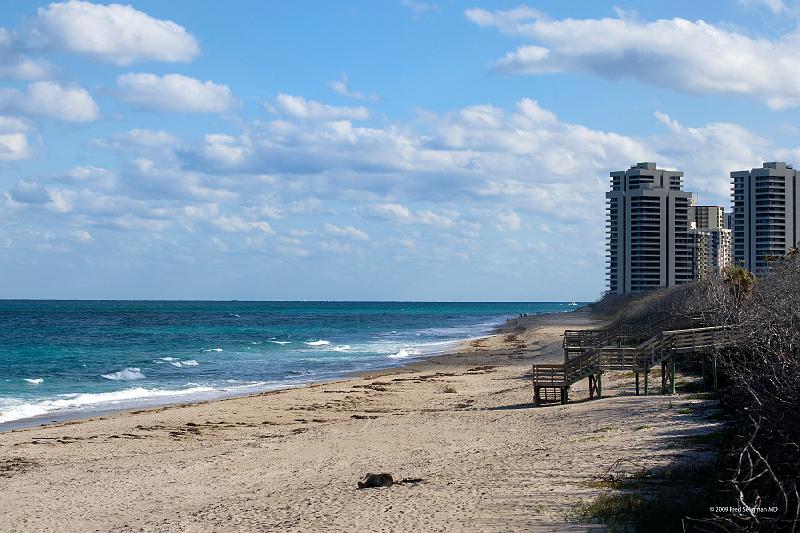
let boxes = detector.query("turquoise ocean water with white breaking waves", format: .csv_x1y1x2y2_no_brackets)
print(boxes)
0,301,576,427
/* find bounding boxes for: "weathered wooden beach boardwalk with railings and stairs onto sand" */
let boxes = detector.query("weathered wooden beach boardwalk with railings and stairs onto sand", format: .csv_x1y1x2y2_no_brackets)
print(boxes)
532,326,730,405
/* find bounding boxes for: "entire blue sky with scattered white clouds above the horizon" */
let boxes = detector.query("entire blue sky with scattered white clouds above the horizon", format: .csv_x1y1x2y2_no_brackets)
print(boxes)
0,0,800,301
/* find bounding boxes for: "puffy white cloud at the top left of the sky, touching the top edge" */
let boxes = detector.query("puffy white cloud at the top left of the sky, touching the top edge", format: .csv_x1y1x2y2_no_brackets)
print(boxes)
23,0,200,65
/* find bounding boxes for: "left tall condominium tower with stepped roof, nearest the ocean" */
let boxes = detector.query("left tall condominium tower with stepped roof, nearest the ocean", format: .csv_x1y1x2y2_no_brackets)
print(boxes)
606,163,694,294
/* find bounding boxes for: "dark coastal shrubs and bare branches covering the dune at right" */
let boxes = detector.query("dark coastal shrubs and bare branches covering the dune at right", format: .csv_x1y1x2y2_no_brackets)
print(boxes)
576,251,800,531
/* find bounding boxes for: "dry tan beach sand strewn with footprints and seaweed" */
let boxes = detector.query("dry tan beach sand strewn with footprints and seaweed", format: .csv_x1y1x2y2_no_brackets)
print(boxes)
0,312,715,531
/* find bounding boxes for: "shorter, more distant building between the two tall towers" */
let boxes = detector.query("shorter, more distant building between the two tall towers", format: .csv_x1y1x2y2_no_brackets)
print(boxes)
689,205,733,279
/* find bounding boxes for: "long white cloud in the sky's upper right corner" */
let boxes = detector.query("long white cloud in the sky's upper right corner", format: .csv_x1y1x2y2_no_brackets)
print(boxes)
465,4,800,109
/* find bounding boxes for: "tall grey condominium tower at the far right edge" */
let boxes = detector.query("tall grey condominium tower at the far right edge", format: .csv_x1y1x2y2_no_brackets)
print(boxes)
731,162,800,274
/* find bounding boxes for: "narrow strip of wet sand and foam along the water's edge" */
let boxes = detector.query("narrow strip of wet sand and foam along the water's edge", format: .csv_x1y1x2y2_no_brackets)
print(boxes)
0,307,582,434
